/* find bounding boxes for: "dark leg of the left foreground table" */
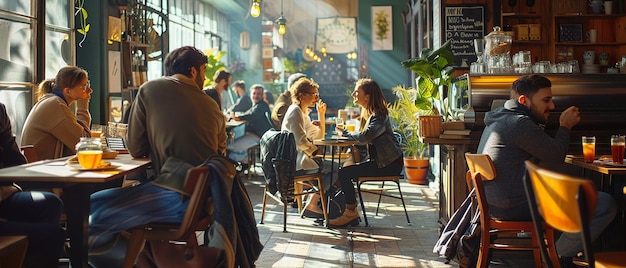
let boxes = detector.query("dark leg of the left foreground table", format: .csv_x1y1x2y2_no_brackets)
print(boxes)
63,183,92,268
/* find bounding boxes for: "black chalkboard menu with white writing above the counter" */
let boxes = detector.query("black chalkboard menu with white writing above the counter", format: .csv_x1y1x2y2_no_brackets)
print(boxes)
443,5,485,68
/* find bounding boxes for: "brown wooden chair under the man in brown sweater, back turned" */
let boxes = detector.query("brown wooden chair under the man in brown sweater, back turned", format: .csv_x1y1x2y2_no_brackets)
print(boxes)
124,166,210,268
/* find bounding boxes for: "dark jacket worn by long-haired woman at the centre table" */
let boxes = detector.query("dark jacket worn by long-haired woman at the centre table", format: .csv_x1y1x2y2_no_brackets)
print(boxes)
348,114,402,168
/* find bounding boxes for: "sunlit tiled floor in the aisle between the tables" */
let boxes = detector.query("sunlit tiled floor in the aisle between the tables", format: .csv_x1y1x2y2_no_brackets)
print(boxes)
245,173,456,267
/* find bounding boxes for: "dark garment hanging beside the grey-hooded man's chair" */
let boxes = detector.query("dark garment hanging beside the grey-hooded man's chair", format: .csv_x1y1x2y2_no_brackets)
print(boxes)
433,189,481,267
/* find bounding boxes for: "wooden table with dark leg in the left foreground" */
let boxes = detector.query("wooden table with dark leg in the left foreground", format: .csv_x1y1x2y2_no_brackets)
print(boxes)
0,154,150,268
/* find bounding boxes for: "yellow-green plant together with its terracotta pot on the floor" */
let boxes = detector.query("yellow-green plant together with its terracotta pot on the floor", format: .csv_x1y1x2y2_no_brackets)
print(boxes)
388,86,434,184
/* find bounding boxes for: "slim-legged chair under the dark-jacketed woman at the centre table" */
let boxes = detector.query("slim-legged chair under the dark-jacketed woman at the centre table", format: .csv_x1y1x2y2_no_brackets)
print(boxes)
356,175,411,226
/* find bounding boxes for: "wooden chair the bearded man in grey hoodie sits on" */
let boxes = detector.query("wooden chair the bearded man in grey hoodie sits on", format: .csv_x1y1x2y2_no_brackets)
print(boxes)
465,153,558,268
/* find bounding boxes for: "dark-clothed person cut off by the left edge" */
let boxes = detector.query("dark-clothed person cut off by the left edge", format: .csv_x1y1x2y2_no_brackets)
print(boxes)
0,103,65,268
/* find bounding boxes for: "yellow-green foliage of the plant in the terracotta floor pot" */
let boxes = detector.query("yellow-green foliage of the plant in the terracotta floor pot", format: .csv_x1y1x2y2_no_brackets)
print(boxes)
388,86,433,158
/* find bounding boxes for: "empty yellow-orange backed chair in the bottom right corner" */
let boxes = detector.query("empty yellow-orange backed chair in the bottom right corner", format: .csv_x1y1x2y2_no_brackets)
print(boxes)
524,161,626,267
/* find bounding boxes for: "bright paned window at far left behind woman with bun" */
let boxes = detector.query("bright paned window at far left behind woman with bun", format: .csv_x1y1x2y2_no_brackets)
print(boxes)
0,0,75,141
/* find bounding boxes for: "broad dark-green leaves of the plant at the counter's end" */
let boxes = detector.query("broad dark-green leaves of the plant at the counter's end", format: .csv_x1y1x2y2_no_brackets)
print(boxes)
401,40,455,121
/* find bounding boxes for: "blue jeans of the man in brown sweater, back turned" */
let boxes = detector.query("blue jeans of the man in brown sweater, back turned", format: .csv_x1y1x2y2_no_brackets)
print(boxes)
89,183,188,248
